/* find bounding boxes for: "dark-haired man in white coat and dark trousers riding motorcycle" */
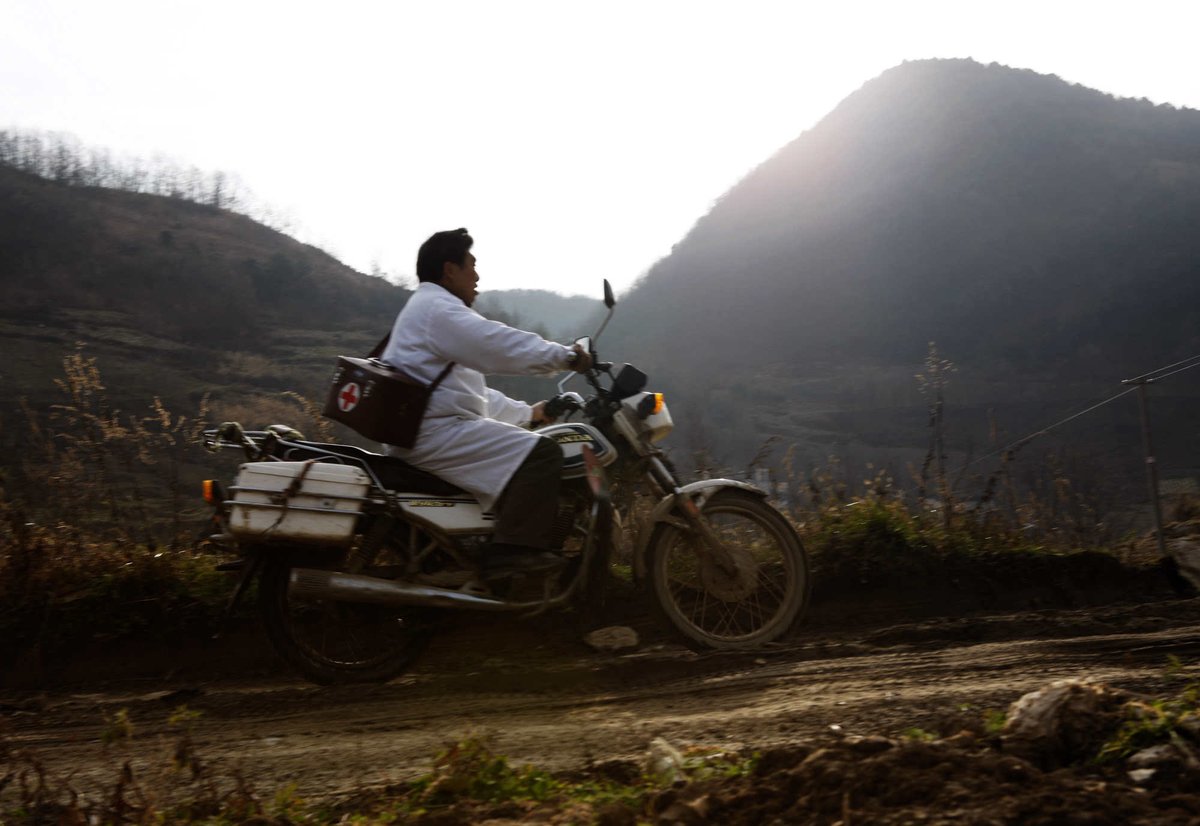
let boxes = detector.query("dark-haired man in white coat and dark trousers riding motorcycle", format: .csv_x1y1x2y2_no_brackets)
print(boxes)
380,229,592,574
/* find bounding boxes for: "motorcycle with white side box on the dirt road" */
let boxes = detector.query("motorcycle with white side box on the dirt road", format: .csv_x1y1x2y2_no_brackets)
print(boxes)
204,281,809,684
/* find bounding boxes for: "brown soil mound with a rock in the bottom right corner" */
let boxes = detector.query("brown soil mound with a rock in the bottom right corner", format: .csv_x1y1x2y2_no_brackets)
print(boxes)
652,680,1200,826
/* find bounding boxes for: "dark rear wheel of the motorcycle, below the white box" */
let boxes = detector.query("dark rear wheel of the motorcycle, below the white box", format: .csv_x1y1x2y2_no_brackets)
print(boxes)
258,558,433,686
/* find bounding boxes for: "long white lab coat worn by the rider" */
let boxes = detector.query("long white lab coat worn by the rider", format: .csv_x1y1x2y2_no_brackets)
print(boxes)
379,281,571,510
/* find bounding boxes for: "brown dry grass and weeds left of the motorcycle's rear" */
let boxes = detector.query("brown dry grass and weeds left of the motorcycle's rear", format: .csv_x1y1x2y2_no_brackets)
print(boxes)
0,349,324,662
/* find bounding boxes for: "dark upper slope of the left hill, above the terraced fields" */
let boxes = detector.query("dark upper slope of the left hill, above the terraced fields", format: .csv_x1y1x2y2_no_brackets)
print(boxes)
0,160,407,348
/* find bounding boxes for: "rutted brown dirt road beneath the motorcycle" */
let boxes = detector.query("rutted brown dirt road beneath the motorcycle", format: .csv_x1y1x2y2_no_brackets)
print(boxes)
9,600,1200,798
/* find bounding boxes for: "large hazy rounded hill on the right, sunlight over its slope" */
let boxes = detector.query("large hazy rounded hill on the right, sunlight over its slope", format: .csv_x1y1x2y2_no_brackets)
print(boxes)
604,60,1200,489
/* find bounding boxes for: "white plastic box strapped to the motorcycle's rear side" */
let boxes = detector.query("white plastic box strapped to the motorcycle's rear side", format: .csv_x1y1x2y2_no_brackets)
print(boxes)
229,462,370,545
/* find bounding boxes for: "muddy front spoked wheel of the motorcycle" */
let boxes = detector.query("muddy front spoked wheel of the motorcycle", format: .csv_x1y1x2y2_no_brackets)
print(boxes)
647,490,809,648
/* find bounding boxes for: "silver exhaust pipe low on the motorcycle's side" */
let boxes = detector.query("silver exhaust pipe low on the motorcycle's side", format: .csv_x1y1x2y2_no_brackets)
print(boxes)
295,568,515,611
